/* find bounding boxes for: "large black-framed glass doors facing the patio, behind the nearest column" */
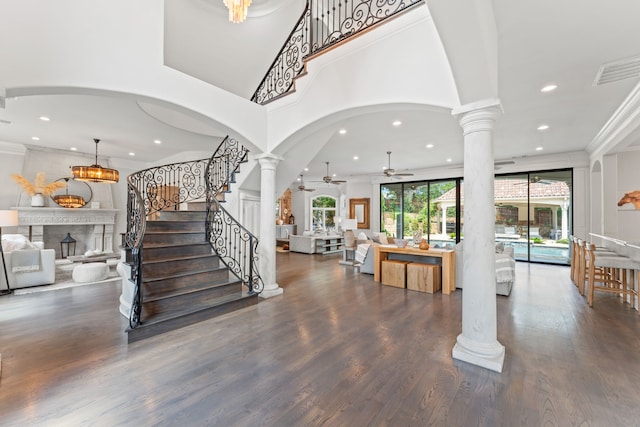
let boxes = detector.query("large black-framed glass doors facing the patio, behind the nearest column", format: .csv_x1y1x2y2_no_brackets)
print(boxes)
380,169,573,264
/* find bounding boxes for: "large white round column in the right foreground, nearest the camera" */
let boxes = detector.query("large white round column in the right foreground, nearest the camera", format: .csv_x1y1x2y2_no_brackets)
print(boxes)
452,100,504,372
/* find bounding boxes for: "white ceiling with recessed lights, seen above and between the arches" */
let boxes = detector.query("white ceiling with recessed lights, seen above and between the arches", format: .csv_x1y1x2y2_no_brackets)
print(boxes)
0,0,640,180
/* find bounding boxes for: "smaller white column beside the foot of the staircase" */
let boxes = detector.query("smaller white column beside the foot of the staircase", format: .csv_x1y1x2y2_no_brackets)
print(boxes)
256,153,284,298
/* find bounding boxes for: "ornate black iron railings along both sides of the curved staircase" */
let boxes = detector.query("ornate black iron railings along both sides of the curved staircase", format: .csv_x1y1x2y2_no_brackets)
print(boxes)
124,137,261,328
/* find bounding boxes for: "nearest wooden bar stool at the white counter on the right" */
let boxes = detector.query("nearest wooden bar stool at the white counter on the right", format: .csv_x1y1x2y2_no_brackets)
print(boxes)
586,244,640,308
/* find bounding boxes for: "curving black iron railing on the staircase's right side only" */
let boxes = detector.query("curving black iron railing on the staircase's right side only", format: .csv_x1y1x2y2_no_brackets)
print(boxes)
206,138,264,294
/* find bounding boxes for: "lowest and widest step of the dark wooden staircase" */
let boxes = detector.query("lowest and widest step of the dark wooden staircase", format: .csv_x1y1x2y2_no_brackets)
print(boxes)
127,292,258,343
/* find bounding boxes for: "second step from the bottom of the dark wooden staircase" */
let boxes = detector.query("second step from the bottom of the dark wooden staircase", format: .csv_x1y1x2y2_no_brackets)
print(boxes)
141,278,242,322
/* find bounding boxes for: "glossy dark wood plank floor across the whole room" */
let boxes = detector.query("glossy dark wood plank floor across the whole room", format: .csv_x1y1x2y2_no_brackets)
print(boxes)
0,253,640,427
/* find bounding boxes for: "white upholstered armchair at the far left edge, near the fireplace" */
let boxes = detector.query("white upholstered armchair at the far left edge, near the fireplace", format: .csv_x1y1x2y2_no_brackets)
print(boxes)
0,235,56,290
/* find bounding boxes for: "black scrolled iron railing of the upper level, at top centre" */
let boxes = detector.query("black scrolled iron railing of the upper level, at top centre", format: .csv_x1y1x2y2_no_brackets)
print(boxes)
251,0,424,104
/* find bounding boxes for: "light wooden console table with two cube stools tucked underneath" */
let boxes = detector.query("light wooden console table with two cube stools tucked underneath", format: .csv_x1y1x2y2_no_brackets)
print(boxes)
373,245,456,295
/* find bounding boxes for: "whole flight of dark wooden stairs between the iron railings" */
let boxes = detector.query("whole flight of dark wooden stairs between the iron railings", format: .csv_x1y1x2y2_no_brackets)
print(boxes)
127,207,258,343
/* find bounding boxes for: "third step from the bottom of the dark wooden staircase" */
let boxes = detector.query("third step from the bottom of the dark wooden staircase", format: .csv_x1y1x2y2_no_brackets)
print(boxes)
142,267,230,300
